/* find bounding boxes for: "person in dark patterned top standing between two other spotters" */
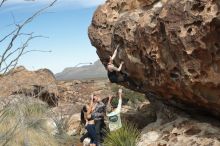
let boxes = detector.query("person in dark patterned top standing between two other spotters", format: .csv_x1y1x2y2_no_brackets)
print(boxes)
92,94,106,146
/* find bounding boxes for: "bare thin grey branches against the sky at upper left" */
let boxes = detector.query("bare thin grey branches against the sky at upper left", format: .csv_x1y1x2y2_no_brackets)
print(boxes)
0,0,57,74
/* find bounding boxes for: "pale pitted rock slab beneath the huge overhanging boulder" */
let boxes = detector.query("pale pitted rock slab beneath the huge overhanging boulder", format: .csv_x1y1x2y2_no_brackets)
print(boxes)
138,99,220,146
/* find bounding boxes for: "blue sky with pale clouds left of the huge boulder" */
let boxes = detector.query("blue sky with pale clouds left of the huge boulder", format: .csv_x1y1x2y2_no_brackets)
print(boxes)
0,0,105,73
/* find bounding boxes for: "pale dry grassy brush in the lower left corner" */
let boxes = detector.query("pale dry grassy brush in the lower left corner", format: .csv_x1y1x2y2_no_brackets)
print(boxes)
0,98,74,146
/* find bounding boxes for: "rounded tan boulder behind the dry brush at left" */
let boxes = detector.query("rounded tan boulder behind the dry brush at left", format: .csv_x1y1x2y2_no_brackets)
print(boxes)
0,67,59,106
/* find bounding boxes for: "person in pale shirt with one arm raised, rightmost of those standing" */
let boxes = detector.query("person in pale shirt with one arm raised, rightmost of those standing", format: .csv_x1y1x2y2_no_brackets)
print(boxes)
107,89,122,131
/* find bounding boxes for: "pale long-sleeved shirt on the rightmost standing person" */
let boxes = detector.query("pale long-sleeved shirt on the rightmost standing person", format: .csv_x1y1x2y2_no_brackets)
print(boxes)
107,98,122,131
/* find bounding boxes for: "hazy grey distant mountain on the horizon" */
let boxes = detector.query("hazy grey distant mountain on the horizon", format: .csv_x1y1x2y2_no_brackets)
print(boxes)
55,60,107,80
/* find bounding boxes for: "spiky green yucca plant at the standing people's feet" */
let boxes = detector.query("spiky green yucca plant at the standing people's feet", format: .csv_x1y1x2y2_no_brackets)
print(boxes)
104,122,140,146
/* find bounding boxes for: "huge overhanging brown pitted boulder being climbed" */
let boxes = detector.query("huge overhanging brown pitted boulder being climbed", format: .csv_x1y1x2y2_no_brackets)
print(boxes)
89,0,220,117
